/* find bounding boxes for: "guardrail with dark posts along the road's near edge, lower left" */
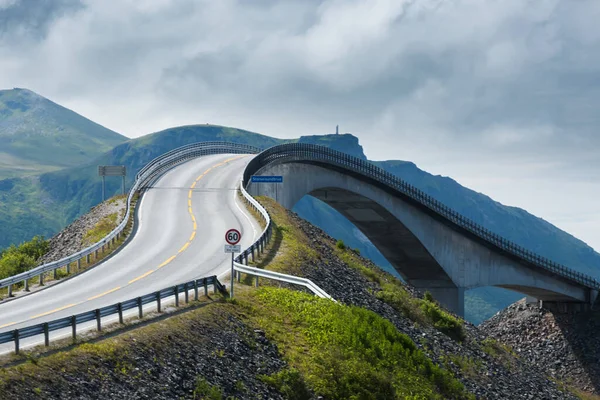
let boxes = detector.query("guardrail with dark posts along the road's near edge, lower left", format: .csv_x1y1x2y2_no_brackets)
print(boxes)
0,276,227,354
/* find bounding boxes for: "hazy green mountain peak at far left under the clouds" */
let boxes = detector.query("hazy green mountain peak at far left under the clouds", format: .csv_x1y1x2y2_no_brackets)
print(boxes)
0,89,127,179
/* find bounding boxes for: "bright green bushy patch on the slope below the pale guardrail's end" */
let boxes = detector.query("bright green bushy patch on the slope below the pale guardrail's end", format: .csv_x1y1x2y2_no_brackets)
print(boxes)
244,287,472,399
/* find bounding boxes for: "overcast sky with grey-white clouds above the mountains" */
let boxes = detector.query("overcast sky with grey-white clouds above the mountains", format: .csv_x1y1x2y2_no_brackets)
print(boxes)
0,0,600,250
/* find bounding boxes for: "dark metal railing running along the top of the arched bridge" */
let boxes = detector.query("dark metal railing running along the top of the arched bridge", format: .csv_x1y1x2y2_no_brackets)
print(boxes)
243,143,600,289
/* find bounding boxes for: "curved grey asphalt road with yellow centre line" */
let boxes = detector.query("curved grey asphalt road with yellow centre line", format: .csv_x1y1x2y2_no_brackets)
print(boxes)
0,154,260,353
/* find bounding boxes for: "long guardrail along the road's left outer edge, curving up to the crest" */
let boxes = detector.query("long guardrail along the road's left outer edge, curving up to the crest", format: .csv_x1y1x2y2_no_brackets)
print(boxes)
0,142,261,296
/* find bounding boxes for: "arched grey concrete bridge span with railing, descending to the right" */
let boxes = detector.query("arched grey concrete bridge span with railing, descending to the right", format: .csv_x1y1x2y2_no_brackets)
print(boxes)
244,144,600,316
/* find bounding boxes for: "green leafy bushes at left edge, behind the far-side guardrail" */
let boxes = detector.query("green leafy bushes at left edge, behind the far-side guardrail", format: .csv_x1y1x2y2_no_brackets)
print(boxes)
0,236,49,279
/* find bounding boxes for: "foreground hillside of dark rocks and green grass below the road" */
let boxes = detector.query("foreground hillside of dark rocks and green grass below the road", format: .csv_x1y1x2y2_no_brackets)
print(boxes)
0,199,588,399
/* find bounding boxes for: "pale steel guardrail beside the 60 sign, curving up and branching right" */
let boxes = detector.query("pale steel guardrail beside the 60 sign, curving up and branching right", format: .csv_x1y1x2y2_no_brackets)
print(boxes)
232,180,335,301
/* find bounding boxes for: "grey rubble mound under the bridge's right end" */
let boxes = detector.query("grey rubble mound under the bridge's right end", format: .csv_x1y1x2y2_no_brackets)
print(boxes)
481,301,600,398
